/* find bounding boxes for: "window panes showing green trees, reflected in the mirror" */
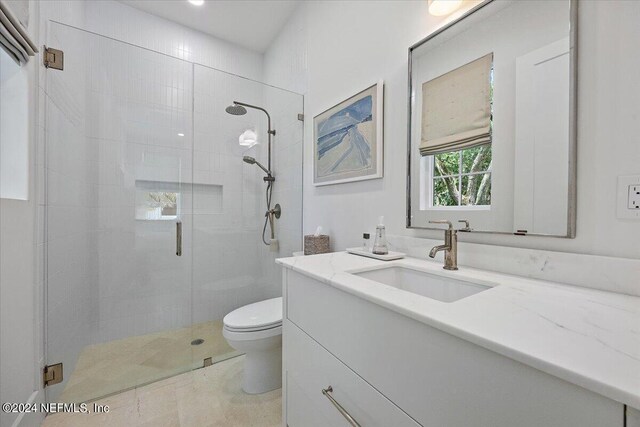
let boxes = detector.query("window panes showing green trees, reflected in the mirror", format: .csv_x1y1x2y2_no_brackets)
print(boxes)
427,144,491,209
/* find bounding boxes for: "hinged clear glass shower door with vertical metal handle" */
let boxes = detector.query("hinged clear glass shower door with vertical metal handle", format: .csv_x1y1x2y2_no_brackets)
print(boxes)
43,23,195,402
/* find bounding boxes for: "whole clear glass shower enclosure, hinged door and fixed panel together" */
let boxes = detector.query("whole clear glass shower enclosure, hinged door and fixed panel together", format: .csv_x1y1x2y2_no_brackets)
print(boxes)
41,22,303,402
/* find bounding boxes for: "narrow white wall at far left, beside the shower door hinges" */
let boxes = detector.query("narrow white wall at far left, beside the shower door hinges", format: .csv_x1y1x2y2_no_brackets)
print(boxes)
0,1,43,427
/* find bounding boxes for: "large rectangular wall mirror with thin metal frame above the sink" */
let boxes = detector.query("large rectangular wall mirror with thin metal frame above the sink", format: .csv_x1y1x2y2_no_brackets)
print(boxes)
407,0,577,237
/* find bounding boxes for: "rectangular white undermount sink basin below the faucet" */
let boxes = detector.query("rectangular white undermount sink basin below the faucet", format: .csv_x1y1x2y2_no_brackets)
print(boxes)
352,266,491,302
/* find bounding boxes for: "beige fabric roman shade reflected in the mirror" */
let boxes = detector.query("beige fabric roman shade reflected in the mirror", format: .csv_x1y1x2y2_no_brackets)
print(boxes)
420,53,493,156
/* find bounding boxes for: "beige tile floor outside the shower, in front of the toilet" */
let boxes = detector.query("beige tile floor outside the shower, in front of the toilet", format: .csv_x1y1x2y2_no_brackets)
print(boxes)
42,356,282,427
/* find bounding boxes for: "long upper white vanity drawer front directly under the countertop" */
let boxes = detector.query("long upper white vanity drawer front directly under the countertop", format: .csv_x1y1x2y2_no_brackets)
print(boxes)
285,271,624,427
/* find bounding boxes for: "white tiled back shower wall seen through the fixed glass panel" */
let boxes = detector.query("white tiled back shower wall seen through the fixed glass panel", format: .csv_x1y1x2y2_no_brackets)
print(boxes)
193,65,266,323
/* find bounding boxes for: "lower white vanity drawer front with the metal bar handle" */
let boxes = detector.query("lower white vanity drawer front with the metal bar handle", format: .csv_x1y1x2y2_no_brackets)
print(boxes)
284,321,419,427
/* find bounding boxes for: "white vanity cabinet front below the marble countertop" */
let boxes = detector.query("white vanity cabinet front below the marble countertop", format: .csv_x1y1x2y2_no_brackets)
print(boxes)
283,269,625,427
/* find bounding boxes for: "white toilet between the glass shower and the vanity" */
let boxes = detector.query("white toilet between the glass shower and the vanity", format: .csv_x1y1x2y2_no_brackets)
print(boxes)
222,297,282,394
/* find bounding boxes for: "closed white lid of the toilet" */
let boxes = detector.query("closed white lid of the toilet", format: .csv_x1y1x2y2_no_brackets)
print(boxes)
222,297,282,330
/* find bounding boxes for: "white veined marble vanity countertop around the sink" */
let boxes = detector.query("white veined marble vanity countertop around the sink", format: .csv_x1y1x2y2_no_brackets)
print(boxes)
276,252,640,408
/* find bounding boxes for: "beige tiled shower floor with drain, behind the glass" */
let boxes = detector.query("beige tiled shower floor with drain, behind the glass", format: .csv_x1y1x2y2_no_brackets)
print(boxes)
58,321,240,403
